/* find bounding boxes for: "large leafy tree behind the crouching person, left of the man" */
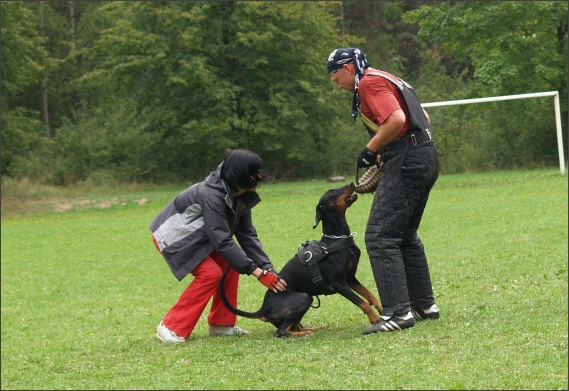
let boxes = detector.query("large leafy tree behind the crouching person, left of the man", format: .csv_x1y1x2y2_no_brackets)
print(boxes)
72,2,344,179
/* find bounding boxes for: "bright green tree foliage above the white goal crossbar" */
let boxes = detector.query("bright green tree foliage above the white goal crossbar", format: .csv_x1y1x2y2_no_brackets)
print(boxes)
403,1,568,99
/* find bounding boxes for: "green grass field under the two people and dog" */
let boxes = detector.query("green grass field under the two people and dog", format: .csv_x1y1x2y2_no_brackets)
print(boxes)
1,169,568,389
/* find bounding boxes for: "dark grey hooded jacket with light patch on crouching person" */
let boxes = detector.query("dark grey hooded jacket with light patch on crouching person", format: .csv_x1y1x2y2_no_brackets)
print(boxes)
150,164,273,281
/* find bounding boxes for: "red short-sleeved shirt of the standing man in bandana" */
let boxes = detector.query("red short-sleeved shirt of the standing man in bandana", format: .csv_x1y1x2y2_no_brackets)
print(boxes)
358,67,410,138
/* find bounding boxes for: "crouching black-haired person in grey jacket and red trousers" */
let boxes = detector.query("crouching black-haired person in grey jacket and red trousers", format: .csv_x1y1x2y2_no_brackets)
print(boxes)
150,149,286,343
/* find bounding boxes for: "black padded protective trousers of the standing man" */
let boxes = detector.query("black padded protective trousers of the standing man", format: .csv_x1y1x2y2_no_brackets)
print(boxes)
365,137,439,317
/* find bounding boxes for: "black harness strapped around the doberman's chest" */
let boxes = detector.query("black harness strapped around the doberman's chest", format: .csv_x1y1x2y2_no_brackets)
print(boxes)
296,236,356,290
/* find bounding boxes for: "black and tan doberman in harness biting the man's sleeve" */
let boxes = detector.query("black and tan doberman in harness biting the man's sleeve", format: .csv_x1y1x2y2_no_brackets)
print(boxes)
220,183,383,337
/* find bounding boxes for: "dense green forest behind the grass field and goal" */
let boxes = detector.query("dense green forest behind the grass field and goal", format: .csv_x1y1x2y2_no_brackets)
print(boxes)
1,1,568,185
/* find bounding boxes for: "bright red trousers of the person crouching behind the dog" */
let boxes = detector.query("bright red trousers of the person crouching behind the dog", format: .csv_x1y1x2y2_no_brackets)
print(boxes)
162,251,239,338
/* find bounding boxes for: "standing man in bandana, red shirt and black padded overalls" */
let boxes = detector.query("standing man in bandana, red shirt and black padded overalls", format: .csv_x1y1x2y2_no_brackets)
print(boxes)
326,48,439,334
